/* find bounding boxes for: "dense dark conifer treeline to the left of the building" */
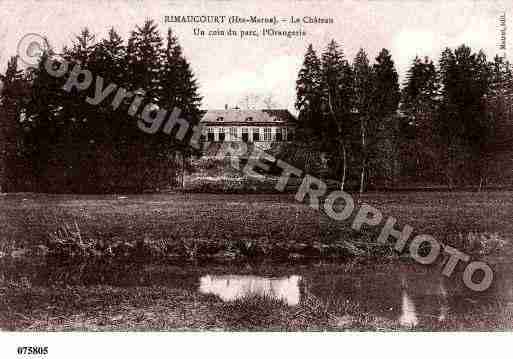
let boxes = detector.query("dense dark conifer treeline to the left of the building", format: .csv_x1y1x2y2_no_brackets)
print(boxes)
0,20,201,193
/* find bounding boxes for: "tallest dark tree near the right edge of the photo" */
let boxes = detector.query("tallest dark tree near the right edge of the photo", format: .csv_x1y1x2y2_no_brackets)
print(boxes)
436,45,493,186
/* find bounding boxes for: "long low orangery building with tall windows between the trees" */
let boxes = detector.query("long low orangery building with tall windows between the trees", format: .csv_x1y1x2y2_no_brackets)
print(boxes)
200,108,296,143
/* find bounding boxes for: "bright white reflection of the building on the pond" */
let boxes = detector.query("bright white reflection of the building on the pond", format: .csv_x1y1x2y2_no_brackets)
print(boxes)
199,275,301,306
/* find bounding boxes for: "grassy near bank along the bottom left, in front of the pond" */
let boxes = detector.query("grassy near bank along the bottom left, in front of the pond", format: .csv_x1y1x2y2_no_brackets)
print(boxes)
0,272,368,331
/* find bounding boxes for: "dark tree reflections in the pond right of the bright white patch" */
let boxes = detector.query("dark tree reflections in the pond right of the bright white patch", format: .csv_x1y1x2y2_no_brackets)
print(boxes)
302,267,506,329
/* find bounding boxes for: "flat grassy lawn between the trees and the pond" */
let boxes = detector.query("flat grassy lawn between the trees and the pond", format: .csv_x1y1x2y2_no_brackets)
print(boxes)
0,192,513,261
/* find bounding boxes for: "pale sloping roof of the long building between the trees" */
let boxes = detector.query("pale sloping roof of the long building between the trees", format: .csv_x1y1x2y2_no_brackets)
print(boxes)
200,109,296,125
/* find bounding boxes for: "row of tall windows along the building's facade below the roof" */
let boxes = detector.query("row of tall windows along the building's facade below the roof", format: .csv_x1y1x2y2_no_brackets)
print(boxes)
204,127,293,142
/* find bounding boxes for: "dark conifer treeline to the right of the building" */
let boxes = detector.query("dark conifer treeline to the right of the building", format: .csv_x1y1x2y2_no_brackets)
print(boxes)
296,40,513,191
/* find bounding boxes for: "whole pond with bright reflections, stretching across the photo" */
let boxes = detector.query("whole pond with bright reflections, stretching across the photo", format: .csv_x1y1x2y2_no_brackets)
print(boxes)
2,263,513,330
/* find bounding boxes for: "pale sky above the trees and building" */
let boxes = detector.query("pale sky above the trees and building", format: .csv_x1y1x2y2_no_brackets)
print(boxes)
0,0,513,110
